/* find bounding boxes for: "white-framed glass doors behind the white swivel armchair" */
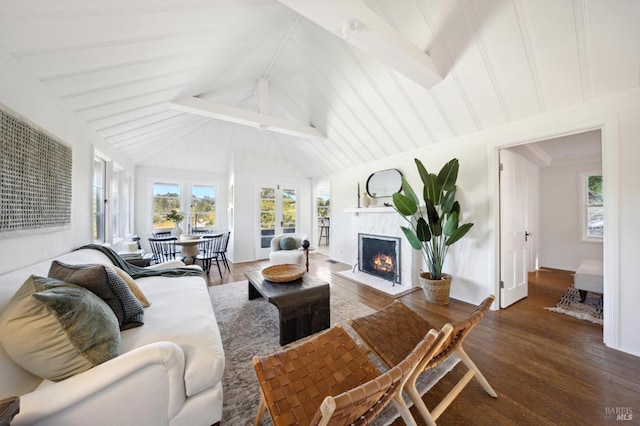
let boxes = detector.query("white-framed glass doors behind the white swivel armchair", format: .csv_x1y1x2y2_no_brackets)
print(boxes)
257,185,298,259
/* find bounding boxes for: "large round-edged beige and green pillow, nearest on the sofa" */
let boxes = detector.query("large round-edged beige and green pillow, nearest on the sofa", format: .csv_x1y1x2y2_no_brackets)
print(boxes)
0,275,120,381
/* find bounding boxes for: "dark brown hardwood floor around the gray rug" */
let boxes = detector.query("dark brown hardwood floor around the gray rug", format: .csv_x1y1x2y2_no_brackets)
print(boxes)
205,254,640,425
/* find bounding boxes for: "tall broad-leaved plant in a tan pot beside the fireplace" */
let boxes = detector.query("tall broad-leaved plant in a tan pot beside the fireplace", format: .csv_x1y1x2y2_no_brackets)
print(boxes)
393,158,473,305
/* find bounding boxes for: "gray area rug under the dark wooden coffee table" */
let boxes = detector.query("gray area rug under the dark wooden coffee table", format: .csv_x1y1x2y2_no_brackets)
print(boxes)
209,281,459,426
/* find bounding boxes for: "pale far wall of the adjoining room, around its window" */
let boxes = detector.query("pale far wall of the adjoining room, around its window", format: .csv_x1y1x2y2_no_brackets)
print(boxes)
540,163,602,271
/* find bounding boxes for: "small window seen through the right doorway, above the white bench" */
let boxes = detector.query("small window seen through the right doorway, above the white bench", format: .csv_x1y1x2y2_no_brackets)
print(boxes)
581,171,604,241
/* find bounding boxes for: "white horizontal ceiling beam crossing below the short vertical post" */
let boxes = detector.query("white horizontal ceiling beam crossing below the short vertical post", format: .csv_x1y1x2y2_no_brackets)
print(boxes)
169,96,326,139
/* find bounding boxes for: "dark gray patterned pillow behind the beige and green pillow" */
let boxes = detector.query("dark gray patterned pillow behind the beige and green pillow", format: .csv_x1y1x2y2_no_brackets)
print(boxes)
49,260,144,330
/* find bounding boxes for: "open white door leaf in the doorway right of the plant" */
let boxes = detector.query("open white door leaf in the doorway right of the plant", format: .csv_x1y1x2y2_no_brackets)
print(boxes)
500,150,530,308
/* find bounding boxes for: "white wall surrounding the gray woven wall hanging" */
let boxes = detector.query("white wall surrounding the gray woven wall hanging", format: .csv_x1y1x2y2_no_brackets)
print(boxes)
0,50,134,274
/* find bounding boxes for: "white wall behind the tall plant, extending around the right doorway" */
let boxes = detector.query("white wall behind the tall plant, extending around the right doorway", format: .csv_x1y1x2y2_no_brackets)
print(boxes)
329,89,640,355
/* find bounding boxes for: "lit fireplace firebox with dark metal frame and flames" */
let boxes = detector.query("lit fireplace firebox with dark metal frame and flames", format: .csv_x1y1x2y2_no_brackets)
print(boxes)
358,233,401,285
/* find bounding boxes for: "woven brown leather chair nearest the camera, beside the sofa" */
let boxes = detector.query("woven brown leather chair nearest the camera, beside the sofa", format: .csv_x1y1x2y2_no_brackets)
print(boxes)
253,325,451,426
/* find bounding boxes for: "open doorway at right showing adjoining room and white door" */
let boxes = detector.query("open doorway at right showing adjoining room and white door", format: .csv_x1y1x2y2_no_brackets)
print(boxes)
499,129,604,307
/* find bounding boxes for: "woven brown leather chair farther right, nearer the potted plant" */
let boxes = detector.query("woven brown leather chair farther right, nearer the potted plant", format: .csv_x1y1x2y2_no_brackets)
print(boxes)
349,295,498,426
